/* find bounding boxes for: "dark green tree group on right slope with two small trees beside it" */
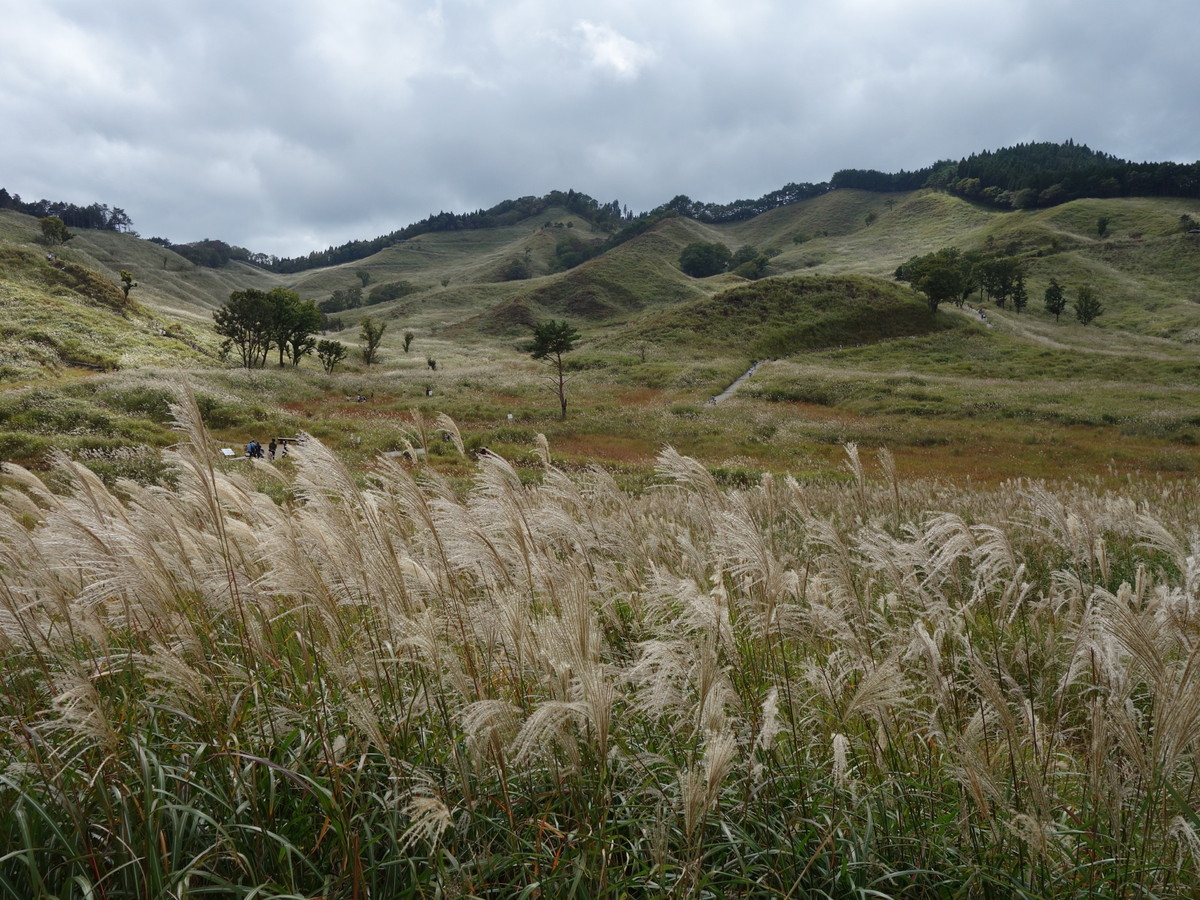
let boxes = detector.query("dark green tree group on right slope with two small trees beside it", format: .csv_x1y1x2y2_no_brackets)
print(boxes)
895,247,1103,325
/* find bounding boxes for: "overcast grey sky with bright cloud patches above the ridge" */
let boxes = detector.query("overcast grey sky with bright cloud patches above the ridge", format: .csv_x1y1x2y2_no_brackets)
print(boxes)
0,0,1200,256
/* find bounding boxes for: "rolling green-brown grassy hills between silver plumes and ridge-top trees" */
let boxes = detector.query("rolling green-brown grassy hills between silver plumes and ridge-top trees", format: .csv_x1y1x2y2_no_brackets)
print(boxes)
0,190,1200,487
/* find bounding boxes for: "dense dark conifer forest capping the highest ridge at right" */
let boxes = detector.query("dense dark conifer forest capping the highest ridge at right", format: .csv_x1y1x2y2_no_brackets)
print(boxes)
830,140,1200,209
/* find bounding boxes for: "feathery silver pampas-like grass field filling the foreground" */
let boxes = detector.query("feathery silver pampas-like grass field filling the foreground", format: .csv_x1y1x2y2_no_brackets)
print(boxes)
0,390,1200,900
